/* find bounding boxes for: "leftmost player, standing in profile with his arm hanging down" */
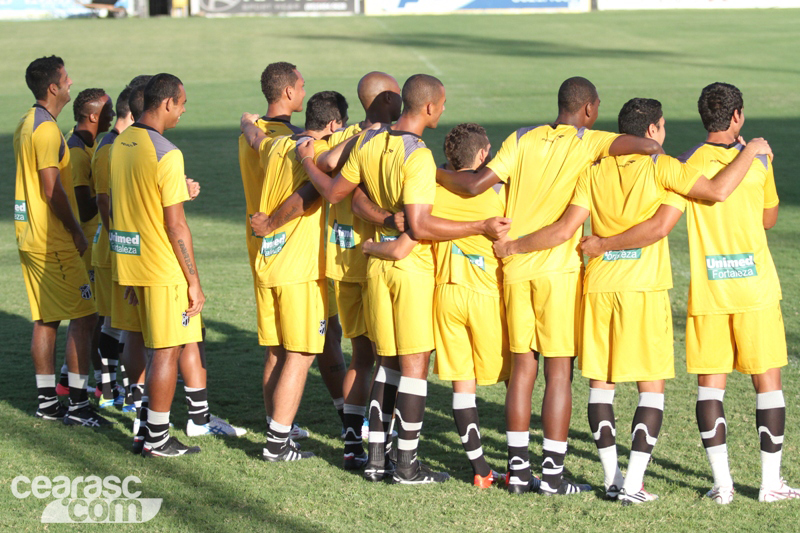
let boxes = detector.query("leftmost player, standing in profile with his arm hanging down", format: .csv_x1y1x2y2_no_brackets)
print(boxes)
14,56,110,427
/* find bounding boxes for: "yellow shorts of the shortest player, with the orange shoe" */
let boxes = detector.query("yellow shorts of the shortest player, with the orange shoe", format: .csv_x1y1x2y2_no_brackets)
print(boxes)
433,284,511,385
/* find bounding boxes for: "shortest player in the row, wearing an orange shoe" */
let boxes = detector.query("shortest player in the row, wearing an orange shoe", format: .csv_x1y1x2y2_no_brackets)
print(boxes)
363,124,511,488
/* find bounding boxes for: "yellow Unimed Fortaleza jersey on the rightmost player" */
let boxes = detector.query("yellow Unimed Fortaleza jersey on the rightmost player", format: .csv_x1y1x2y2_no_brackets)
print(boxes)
680,143,781,316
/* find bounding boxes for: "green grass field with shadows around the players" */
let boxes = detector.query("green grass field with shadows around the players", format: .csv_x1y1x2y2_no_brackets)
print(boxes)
0,10,800,532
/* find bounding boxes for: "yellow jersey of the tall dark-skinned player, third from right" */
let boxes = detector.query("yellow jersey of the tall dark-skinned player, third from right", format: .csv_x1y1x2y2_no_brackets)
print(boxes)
487,124,618,284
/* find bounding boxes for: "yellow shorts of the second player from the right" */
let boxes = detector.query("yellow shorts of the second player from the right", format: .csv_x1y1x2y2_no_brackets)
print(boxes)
578,290,675,383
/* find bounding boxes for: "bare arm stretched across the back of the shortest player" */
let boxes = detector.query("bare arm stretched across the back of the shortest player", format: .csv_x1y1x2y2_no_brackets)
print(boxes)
404,204,511,241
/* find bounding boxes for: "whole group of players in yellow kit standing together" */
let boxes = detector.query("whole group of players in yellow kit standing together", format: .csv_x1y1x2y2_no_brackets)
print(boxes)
15,53,800,504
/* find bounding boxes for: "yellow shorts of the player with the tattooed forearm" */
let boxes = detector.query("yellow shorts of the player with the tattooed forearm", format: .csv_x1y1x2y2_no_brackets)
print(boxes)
135,285,203,350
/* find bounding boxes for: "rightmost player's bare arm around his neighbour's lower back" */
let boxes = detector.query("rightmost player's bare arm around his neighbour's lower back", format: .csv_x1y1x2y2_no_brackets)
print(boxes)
581,204,683,257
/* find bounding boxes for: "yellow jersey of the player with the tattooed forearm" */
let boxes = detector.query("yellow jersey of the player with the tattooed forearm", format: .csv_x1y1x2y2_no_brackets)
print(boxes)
108,123,189,287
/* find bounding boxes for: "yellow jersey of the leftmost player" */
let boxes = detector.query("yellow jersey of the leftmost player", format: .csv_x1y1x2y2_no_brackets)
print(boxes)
14,104,76,253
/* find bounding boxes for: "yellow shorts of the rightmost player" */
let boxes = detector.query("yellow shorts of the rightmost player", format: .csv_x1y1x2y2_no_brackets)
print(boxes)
686,303,788,374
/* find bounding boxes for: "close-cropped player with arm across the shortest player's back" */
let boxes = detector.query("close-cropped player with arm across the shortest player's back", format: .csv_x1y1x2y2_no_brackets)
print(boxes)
298,74,508,484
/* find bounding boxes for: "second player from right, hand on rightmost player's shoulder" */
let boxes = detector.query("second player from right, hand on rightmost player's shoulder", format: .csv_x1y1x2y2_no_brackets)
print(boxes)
495,98,769,505
